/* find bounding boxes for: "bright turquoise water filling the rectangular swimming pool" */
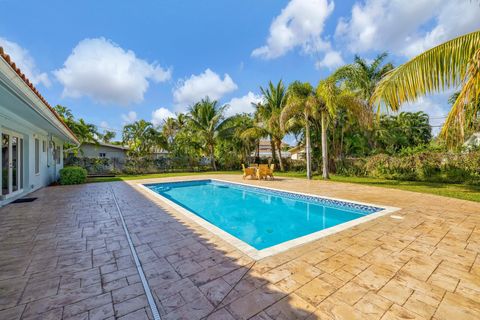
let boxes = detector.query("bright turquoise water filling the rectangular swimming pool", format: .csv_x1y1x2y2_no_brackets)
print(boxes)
146,180,383,250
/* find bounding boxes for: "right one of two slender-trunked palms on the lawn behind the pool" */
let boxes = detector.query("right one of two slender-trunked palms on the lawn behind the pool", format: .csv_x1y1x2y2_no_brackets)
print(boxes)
316,76,365,179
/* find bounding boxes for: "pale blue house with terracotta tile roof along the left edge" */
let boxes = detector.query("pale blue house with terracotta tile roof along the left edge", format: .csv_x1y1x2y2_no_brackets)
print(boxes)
0,47,78,206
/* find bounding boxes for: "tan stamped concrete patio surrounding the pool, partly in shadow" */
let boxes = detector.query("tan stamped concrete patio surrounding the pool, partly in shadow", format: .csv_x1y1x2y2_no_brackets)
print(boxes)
0,175,480,320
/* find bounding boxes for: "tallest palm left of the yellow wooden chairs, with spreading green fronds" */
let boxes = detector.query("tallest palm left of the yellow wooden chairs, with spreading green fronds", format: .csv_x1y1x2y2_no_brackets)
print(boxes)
190,97,228,171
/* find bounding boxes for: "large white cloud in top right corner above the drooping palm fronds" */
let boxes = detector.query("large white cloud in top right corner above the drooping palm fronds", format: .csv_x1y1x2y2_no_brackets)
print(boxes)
335,0,480,57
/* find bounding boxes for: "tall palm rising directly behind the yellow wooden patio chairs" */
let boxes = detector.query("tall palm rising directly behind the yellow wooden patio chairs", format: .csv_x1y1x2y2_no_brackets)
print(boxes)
256,80,287,171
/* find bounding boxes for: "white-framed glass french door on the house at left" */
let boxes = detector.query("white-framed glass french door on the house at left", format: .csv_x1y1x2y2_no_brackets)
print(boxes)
2,131,24,198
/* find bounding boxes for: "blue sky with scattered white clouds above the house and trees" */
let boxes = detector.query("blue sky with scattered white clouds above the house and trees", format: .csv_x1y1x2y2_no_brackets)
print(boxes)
0,0,480,140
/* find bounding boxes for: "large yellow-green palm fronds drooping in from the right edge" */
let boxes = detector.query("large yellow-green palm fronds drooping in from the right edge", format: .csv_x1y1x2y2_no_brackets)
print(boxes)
371,30,480,145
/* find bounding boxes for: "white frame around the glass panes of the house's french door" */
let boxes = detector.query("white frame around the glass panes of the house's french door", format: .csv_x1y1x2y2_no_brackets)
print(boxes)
0,128,25,199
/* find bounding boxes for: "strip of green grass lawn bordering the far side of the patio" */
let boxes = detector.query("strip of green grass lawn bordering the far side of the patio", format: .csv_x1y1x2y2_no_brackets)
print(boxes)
87,171,480,202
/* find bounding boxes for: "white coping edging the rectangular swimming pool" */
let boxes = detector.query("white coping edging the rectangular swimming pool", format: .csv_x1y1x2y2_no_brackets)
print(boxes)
136,178,400,260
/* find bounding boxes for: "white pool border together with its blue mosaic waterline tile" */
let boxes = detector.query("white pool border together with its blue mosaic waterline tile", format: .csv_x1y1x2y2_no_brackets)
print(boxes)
137,179,400,260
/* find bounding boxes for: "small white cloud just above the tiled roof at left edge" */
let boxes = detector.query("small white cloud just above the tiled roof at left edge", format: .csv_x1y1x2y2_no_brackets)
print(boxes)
0,37,51,87
